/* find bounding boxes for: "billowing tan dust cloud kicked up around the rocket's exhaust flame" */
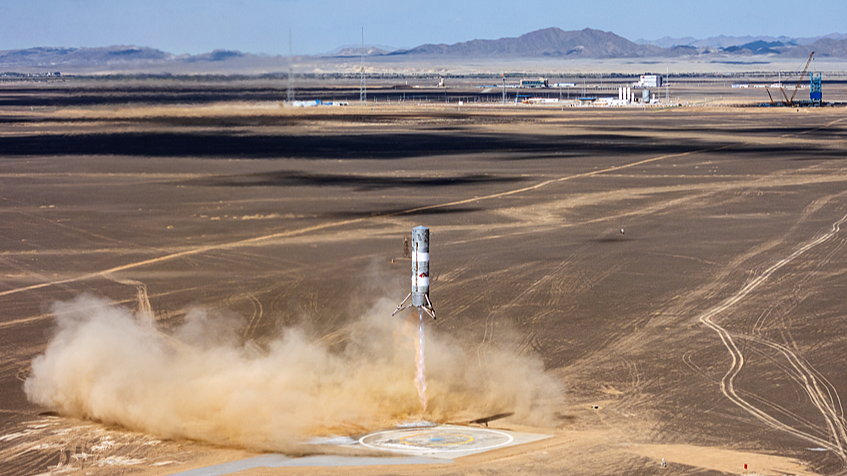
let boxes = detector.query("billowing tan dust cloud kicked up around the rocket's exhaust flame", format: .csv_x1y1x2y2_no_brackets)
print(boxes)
24,295,562,452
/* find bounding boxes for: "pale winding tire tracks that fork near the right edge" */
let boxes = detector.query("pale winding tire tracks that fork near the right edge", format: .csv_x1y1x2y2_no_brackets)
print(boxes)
699,215,847,463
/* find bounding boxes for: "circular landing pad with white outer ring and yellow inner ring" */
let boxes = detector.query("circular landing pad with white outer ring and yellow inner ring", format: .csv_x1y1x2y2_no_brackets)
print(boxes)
359,425,514,456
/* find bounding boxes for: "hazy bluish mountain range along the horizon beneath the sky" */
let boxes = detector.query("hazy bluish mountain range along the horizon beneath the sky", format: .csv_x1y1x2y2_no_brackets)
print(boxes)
0,28,847,72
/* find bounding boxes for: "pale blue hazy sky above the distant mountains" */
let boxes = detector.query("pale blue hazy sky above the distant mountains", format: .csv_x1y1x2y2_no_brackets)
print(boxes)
0,0,847,54
